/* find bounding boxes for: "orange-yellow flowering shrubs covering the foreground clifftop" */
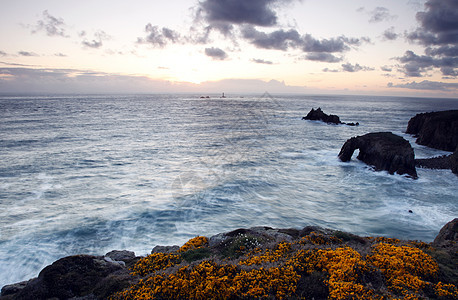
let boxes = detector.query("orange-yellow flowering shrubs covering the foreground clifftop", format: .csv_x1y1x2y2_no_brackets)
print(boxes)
111,232,458,300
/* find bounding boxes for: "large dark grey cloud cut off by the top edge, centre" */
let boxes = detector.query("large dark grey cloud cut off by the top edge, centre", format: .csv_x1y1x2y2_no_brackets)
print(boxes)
199,0,290,26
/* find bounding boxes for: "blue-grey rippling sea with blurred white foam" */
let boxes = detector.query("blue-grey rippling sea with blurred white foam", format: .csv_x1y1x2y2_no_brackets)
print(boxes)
0,94,458,287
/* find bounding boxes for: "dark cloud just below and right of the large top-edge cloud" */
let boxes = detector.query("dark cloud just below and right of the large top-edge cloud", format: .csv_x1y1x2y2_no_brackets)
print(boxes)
242,25,302,51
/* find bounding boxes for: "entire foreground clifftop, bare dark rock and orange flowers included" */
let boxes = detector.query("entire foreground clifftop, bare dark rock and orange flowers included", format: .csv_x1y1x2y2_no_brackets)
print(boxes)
0,218,458,300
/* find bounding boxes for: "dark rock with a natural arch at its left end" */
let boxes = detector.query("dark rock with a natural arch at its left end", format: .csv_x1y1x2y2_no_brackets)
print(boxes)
339,132,417,178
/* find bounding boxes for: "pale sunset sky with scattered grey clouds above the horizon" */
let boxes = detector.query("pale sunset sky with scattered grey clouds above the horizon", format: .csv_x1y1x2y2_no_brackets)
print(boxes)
0,0,458,98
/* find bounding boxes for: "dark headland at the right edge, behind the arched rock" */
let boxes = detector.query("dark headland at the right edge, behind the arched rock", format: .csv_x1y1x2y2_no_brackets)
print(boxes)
406,110,458,151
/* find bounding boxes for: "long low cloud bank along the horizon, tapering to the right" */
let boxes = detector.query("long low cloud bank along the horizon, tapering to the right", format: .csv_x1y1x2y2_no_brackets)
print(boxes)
0,67,306,94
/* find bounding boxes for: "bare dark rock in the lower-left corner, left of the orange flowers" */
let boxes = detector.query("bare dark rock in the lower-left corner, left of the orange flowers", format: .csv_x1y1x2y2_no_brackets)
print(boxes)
0,251,135,300
